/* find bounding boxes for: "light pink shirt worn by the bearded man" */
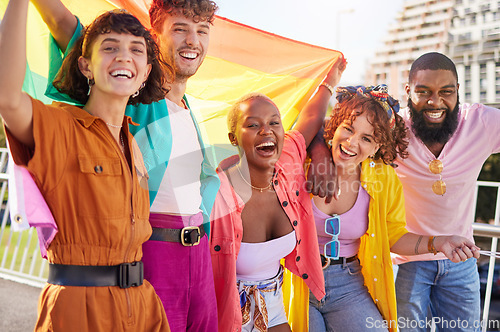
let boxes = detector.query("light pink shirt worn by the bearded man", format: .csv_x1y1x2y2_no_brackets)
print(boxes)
394,104,500,264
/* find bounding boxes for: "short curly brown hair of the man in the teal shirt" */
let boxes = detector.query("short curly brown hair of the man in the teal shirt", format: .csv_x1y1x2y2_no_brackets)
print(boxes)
149,0,219,33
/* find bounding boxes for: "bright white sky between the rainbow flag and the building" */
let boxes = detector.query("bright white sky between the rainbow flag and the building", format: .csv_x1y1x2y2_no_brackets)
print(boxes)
216,0,404,85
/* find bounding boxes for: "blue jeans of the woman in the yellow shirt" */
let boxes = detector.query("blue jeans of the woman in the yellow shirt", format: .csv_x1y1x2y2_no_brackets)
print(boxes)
309,260,387,332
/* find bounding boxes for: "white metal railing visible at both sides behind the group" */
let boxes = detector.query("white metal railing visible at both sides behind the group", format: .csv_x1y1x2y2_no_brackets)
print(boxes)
0,148,500,331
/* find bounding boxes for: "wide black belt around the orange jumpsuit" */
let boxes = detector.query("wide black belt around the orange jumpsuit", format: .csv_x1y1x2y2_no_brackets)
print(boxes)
47,262,144,288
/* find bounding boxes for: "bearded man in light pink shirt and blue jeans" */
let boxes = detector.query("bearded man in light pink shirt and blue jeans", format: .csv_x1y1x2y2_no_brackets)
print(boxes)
394,53,500,331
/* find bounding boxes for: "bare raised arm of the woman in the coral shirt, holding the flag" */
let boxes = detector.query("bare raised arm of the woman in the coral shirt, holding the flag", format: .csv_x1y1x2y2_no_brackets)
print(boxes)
293,57,347,146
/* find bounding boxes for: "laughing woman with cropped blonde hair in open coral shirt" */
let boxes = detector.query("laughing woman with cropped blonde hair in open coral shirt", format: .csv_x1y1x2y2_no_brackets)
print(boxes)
210,58,346,331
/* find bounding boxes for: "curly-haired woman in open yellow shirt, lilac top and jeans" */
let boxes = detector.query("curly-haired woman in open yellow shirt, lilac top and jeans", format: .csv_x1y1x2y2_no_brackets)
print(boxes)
309,85,479,332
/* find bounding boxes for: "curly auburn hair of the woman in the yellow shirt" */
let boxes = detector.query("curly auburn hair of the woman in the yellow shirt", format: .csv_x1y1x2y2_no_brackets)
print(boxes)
324,95,408,165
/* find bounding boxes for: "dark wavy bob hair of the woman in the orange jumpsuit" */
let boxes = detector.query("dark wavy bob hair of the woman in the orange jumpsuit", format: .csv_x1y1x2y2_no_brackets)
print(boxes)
53,9,174,105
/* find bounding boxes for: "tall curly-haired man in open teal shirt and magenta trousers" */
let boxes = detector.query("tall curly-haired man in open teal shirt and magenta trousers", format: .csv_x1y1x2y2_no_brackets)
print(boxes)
32,0,219,332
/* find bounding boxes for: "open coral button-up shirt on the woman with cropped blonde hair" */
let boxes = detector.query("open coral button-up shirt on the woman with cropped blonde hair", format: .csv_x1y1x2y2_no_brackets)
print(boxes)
210,131,325,332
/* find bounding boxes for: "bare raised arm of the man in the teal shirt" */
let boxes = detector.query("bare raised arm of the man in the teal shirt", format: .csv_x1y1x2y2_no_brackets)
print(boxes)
31,0,78,52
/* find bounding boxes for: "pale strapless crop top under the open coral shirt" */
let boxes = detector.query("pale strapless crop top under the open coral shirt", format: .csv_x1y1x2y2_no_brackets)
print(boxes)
236,231,297,281
